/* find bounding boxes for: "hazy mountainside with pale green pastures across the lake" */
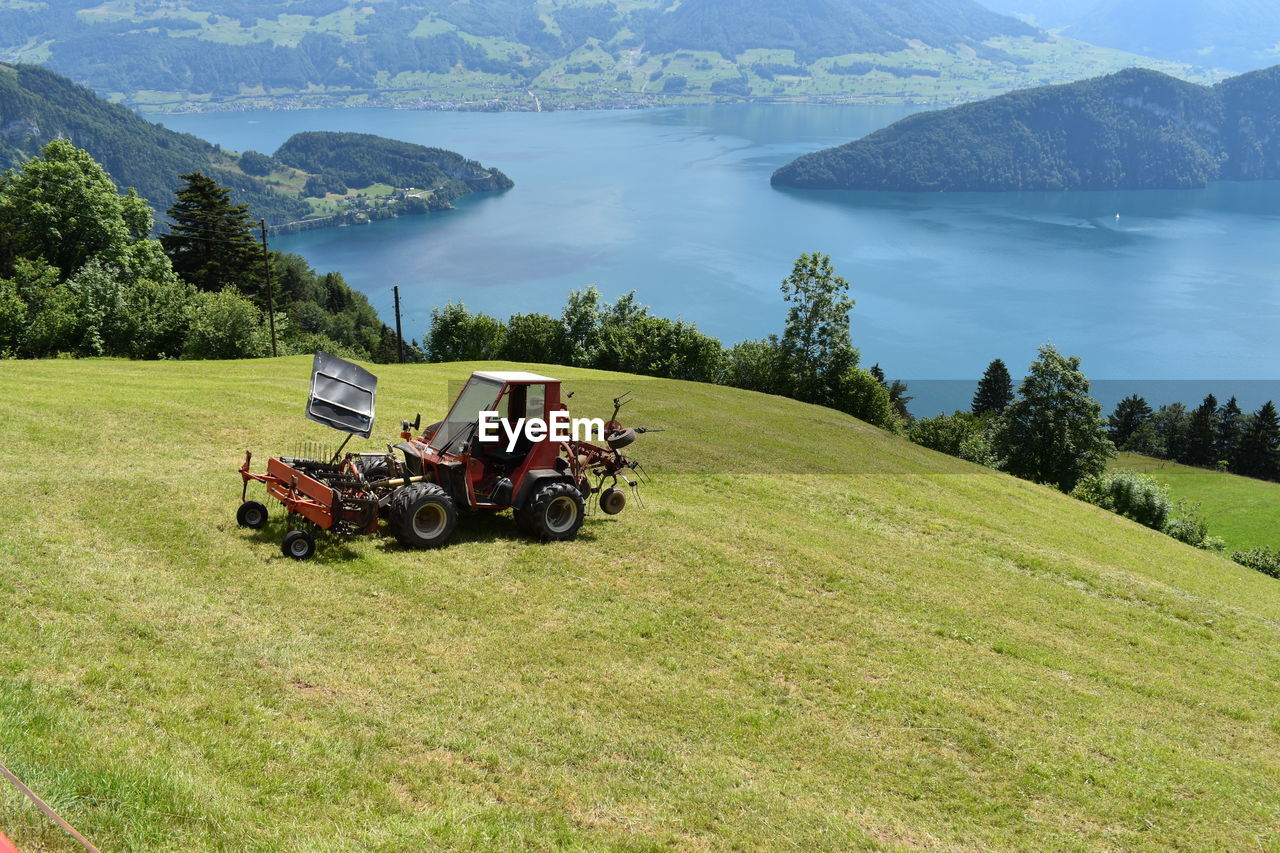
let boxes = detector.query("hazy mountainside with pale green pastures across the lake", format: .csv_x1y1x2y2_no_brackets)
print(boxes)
0,0,1208,109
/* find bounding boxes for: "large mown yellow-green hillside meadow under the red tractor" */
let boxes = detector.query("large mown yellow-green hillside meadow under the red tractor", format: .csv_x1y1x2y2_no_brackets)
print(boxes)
0,357,1280,852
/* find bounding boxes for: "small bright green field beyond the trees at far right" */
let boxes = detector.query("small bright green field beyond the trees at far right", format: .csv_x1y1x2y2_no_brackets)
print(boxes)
1112,453,1280,549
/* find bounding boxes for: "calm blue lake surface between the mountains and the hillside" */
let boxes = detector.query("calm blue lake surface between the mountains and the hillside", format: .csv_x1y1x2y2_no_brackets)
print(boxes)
163,105,1280,409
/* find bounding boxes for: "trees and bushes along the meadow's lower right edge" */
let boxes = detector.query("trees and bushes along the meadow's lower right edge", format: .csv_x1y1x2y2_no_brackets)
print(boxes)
908,345,1280,578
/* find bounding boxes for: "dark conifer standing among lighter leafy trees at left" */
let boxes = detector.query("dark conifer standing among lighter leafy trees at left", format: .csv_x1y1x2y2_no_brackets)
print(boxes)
160,172,264,295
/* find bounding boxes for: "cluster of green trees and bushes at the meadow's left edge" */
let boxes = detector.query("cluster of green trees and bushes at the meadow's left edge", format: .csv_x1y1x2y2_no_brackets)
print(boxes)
0,140,421,361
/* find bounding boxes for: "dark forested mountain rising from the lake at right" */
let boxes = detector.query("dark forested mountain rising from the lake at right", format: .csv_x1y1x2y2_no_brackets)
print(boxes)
773,67,1280,192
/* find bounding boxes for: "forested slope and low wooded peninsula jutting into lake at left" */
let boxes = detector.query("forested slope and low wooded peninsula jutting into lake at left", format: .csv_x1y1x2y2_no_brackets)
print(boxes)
0,64,512,224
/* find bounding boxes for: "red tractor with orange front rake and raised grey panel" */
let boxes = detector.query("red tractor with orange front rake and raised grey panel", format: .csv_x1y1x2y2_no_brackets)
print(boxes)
236,352,650,560
